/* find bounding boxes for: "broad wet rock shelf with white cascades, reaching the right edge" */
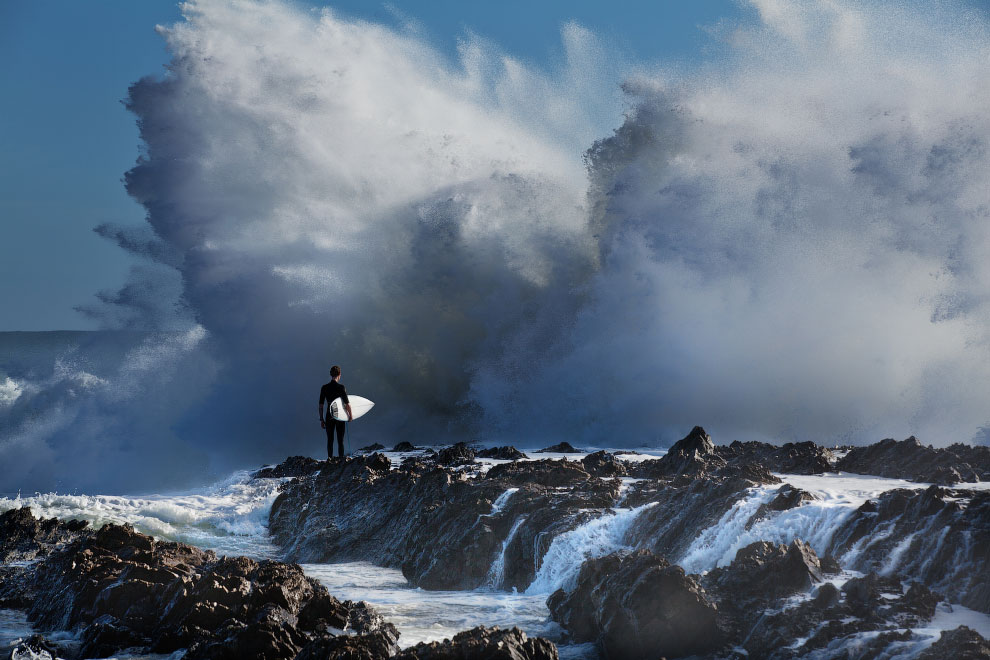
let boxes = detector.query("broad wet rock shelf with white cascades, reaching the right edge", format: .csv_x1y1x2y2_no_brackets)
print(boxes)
270,427,990,658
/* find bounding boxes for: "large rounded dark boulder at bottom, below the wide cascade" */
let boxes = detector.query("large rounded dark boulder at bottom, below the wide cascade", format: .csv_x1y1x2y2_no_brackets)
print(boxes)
547,550,725,659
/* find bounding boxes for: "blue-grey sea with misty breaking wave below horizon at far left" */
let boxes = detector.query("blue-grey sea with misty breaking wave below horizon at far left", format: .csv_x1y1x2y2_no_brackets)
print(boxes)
0,326,215,495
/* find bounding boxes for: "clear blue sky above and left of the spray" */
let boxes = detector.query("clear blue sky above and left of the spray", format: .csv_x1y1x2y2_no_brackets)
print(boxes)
0,0,745,330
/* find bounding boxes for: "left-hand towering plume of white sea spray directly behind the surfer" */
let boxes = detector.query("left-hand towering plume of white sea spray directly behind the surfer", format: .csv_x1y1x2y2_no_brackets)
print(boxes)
114,2,619,474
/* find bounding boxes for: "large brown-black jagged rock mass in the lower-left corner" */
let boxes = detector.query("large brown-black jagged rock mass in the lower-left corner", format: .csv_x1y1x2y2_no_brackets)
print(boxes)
4,516,398,660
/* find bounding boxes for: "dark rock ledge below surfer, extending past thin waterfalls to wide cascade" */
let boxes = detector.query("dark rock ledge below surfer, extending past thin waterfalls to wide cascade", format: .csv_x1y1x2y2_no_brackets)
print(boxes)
269,455,619,589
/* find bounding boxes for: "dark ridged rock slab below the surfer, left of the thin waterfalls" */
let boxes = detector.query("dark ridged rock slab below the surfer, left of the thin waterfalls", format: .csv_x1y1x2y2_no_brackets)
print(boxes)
269,454,511,589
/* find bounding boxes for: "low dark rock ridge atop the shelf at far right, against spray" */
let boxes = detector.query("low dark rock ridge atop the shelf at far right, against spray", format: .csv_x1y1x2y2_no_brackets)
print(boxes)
837,436,990,486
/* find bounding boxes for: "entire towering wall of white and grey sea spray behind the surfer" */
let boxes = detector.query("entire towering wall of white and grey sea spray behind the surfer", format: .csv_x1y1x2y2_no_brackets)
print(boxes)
0,0,990,488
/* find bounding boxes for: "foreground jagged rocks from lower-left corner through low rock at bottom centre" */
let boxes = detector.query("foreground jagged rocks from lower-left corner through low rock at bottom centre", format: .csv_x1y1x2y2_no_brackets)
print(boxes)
0,508,557,660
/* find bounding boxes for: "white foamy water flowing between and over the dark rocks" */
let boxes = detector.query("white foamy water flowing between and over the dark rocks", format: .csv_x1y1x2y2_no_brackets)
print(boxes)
0,452,990,660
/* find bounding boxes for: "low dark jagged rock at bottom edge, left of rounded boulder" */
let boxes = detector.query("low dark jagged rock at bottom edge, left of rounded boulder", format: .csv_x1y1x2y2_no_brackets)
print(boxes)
395,626,558,660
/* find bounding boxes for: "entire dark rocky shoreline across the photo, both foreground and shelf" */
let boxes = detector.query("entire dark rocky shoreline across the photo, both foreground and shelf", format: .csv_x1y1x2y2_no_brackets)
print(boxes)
0,427,990,660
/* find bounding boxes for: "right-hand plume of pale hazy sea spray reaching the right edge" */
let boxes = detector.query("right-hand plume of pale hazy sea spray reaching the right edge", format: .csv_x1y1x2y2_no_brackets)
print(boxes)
486,2,990,445
